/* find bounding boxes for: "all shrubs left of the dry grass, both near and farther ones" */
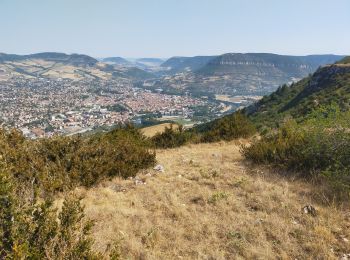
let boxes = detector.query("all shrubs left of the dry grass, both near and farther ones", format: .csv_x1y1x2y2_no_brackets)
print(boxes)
0,126,155,259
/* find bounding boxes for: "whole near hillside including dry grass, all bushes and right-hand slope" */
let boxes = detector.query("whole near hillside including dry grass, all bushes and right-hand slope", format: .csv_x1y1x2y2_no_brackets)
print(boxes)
0,59,350,260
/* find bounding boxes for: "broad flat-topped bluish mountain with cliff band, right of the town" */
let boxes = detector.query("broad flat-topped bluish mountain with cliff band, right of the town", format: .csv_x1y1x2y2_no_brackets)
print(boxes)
153,53,344,97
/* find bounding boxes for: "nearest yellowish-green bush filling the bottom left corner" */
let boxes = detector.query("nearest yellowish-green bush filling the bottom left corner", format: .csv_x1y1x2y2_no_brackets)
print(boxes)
0,168,99,259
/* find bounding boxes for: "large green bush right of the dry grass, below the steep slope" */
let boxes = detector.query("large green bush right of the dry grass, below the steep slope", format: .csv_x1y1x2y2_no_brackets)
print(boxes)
242,106,350,193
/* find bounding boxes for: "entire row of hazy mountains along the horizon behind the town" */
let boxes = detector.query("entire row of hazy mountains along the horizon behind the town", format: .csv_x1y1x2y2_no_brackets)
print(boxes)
0,52,344,87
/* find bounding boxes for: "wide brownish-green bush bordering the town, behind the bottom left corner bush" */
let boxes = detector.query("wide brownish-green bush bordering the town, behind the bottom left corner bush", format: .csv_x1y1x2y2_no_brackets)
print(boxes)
0,126,155,194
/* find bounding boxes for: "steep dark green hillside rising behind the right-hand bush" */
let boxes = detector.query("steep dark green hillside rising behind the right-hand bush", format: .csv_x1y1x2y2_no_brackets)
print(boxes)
245,57,350,125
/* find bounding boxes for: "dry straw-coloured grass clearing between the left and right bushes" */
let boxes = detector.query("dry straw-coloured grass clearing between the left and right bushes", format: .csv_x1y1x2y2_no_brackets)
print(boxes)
65,141,350,259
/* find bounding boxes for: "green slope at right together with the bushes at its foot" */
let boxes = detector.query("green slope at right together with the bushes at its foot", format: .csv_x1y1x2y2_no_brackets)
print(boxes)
242,58,350,196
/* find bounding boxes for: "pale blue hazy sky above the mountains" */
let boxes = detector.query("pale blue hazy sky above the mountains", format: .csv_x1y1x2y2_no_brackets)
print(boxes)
0,0,350,58
